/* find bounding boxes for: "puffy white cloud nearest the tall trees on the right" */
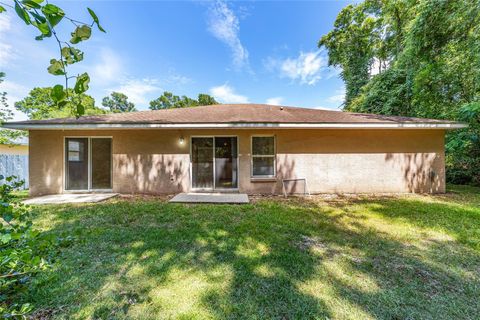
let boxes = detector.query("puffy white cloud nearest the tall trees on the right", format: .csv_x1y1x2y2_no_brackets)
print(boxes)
265,51,328,85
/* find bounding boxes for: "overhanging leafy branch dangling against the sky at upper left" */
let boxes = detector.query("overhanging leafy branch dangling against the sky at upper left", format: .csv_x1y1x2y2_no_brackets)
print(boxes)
0,0,105,116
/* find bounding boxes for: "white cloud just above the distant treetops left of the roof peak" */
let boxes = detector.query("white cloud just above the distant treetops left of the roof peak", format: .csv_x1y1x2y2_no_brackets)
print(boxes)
109,78,161,105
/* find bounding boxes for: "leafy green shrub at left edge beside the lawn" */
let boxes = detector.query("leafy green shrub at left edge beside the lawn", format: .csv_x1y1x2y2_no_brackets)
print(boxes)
0,176,70,318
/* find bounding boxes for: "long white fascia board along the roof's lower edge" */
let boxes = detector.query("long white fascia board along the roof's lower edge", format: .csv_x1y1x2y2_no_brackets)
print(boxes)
2,122,468,130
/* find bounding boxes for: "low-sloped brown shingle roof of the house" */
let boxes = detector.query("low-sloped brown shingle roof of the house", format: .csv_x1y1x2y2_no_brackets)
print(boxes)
6,104,455,127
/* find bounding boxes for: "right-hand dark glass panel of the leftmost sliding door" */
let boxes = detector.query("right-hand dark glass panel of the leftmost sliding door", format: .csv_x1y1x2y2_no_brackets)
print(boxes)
91,138,112,189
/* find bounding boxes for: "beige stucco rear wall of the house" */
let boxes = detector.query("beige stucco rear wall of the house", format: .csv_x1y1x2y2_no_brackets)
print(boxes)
29,129,445,195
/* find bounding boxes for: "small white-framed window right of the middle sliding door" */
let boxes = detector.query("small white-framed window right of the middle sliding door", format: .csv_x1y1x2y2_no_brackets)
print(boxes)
252,136,275,178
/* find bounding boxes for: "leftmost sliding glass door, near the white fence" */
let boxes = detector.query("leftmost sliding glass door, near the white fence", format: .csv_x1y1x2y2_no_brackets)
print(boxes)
65,137,112,191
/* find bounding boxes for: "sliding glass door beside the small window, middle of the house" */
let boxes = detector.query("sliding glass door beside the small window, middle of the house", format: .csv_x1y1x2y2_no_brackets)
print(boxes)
191,137,238,190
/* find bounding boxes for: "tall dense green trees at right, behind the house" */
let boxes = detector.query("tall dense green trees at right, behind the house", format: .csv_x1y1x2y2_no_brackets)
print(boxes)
319,0,480,185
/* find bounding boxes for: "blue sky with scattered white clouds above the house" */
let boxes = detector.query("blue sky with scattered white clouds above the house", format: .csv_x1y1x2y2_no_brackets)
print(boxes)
0,1,348,119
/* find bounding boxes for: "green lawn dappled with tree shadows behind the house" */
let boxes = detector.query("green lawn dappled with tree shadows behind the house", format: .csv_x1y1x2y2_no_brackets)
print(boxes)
20,186,480,319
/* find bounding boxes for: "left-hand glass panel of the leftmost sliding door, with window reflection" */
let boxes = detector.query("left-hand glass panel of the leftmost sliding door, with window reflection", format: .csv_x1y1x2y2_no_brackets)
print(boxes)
65,138,88,190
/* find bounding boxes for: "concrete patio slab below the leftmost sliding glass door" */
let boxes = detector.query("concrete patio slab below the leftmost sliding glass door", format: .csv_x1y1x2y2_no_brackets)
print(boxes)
23,193,118,205
